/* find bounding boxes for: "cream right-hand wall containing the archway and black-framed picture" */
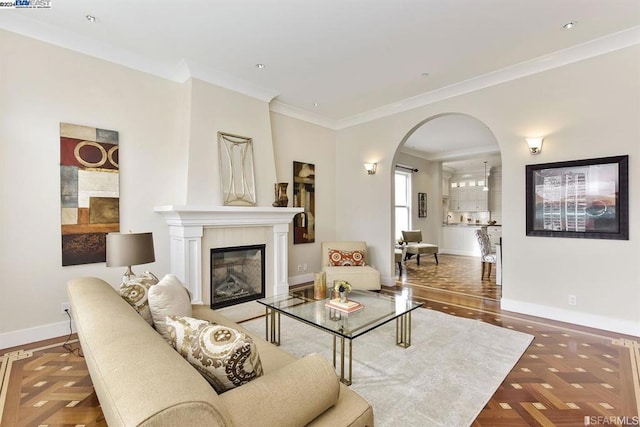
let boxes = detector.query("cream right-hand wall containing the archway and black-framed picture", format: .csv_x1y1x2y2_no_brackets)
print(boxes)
336,46,640,335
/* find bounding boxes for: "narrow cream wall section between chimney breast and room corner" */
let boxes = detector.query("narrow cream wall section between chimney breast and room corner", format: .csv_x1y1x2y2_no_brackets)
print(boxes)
271,113,338,284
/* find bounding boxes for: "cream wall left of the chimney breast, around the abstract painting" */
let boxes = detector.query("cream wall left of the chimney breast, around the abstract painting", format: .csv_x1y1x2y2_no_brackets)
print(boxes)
0,31,181,348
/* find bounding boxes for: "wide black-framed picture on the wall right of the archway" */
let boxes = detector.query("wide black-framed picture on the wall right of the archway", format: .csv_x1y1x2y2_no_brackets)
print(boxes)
526,156,629,240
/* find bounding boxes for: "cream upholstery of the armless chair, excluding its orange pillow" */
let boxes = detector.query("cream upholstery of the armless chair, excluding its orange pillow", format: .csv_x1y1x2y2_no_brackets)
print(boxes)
320,241,380,290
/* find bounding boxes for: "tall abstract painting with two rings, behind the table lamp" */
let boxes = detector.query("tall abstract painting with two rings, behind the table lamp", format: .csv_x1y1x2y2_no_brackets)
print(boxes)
60,123,120,266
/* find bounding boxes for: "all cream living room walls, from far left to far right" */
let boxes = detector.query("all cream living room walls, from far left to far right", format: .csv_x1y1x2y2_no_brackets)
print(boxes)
0,31,640,348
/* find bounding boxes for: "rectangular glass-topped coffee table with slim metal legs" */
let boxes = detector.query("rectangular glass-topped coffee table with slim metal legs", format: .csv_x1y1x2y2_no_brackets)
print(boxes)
257,291,422,385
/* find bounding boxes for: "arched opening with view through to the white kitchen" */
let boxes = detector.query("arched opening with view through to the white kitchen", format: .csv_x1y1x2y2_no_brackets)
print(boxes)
391,113,502,299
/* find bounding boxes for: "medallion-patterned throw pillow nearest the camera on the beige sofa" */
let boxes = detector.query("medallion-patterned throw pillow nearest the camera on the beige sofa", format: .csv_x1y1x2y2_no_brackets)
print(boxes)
166,316,262,394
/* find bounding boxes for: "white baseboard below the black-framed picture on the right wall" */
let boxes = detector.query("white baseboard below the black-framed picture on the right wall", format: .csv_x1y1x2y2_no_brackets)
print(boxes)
500,298,640,337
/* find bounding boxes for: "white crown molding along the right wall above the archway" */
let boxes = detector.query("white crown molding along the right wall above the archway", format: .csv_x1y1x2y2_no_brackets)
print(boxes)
336,26,640,130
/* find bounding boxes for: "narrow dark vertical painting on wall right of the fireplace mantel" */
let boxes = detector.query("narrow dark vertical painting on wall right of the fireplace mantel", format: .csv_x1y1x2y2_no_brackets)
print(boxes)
293,162,316,244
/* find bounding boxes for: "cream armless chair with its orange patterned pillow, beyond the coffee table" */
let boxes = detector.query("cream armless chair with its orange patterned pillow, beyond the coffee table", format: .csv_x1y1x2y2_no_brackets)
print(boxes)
321,241,380,290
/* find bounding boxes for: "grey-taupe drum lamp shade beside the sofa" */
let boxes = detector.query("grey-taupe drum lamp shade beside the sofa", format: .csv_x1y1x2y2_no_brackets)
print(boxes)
107,233,156,267
